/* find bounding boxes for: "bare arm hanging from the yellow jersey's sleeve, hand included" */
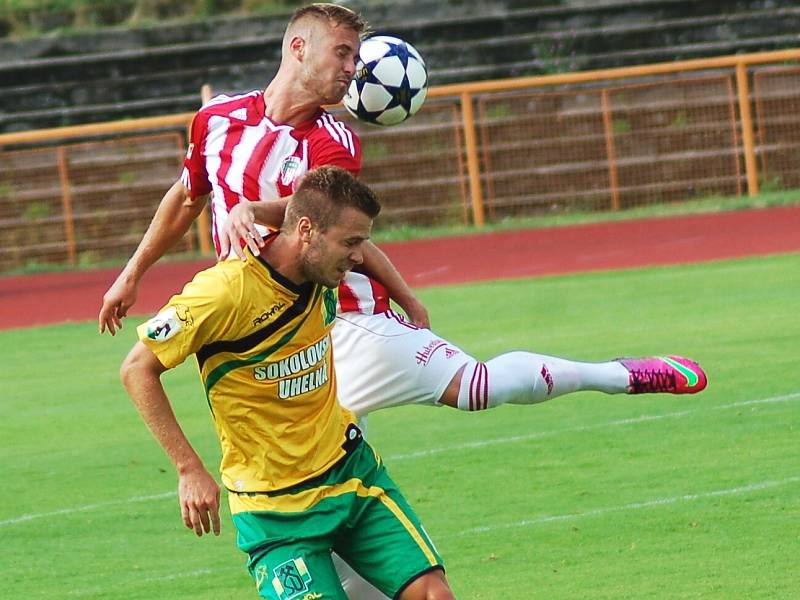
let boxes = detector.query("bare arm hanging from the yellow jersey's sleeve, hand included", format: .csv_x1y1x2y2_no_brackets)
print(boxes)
120,342,220,537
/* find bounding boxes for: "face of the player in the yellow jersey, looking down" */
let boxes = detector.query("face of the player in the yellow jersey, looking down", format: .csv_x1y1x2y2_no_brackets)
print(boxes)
301,207,372,288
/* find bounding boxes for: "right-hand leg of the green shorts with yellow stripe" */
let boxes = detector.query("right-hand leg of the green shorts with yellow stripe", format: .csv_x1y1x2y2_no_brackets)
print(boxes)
334,458,443,597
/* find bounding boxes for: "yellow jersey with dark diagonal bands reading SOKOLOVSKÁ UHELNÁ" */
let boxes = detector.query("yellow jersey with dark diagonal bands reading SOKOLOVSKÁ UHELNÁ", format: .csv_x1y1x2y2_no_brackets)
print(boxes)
138,243,355,492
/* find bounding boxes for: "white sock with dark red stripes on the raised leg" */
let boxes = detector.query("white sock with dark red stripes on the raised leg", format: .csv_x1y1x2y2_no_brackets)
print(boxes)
458,352,628,410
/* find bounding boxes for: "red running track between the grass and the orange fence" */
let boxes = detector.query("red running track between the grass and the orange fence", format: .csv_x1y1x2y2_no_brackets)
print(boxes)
0,206,800,329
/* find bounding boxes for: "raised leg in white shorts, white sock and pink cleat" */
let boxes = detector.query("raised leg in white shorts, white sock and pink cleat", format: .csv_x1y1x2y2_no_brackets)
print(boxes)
333,311,706,415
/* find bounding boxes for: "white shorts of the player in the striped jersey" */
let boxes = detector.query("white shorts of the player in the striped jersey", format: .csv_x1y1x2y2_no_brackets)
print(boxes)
332,311,474,416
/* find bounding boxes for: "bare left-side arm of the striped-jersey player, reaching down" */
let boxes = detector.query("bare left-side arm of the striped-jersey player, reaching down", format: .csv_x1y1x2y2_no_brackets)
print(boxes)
97,181,205,335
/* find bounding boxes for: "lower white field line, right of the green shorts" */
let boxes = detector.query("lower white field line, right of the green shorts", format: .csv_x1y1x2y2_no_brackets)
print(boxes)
446,476,800,537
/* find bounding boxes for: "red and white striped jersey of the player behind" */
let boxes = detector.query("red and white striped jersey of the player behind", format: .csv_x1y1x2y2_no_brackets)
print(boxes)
181,90,389,314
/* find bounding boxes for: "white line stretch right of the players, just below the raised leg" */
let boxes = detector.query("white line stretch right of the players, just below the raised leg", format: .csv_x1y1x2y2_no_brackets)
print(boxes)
385,392,800,462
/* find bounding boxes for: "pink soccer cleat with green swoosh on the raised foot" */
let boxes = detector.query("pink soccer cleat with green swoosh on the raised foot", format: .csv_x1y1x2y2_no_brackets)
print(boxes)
619,356,708,394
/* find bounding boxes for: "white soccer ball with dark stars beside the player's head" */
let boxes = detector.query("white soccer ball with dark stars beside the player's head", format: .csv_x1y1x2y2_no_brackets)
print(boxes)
343,35,428,125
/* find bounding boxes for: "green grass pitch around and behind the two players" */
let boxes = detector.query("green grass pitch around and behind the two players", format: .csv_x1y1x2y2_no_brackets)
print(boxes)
0,255,800,600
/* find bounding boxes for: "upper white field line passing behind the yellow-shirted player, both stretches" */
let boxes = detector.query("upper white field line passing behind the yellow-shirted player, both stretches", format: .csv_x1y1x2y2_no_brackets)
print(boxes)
0,392,800,527
